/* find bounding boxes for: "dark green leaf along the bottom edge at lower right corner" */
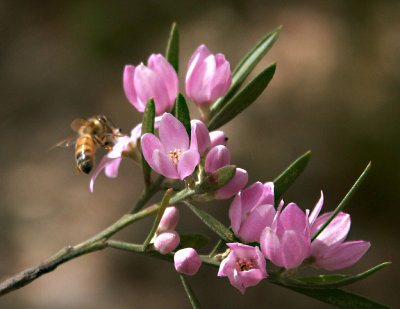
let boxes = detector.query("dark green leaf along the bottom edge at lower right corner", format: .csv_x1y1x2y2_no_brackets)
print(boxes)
289,287,389,309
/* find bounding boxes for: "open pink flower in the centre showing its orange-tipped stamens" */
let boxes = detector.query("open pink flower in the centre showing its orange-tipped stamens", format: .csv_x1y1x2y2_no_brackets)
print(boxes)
141,113,200,180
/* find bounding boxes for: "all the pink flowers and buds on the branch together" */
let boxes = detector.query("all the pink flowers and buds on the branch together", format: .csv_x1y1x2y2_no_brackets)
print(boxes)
90,33,370,293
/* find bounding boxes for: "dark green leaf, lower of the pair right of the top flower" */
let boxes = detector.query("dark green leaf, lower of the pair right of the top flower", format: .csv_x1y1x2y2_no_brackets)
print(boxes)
208,63,276,131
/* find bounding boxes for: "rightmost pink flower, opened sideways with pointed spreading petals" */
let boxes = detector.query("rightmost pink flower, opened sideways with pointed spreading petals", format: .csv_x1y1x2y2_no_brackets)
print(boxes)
309,191,371,270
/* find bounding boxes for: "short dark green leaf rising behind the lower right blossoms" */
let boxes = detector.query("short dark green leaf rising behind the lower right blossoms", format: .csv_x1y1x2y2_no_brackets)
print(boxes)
274,151,311,205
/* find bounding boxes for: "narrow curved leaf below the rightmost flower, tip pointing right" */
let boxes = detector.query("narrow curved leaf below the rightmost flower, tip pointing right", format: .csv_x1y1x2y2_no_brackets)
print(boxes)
288,262,391,289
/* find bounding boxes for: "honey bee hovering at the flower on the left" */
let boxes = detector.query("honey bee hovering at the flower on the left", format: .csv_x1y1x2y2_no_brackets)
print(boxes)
52,115,122,174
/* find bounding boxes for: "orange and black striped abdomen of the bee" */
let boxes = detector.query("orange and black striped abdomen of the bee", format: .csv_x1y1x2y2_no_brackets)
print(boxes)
75,135,96,174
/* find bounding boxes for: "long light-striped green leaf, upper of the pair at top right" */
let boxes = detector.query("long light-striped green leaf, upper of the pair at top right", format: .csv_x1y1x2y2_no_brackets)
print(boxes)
210,27,281,116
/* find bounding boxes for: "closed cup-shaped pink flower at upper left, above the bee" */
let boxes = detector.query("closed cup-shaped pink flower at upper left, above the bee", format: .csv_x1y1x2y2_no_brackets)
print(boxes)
123,54,178,115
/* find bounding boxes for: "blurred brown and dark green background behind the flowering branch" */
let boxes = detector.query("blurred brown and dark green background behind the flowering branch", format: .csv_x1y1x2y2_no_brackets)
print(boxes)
0,0,400,308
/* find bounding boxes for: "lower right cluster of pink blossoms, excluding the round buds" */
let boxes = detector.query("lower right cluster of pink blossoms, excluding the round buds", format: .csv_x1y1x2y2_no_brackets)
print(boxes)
218,182,370,293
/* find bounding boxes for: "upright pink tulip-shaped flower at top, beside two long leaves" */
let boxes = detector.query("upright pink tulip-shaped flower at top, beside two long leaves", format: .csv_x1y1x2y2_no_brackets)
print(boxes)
186,45,232,105
